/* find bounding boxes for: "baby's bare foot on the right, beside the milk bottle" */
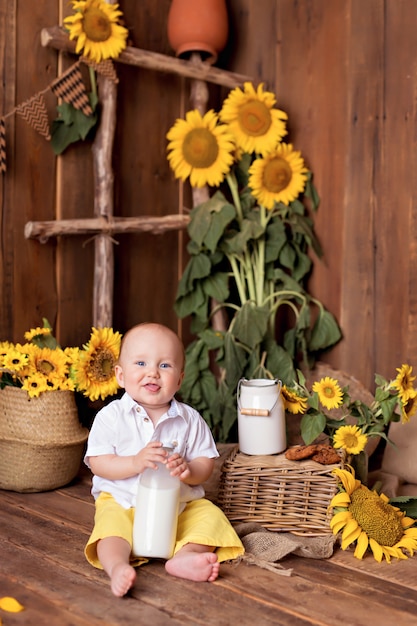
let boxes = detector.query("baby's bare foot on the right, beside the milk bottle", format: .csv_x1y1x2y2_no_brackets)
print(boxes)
165,551,220,583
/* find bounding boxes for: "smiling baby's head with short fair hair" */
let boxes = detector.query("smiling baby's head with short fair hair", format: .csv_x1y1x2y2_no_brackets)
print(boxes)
116,325,184,408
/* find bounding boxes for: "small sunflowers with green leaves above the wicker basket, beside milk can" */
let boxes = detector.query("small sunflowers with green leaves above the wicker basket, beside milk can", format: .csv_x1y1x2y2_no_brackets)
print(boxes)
282,364,417,455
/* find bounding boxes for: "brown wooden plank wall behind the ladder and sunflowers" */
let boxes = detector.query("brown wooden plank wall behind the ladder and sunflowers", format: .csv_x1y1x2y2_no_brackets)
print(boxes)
0,0,417,387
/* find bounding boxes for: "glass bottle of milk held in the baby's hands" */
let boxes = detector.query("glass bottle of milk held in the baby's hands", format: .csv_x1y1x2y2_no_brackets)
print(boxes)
133,446,181,559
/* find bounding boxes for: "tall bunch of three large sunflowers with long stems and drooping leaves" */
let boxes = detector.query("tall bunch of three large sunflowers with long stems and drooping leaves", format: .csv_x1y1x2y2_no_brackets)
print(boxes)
167,82,341,441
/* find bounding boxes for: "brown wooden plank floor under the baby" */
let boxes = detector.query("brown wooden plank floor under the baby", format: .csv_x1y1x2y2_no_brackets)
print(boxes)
0,444,417,626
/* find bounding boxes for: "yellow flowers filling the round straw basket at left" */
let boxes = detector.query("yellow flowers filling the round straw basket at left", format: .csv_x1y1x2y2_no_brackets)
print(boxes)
0,319,121,400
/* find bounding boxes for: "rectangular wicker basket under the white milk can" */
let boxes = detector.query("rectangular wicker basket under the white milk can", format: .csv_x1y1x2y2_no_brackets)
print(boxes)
217,446,343,536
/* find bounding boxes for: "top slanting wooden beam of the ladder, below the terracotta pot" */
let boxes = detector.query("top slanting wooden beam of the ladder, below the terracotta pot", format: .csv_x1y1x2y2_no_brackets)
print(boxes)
41,26,253,89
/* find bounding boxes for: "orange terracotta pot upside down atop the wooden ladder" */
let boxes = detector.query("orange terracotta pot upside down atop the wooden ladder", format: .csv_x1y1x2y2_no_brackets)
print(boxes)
167,0,228,63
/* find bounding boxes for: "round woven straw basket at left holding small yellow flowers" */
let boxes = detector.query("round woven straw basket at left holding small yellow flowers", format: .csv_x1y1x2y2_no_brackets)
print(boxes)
0,387,88,492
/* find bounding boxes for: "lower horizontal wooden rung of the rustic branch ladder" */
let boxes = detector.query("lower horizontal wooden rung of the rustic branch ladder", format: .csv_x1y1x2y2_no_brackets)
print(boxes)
25,215,190,243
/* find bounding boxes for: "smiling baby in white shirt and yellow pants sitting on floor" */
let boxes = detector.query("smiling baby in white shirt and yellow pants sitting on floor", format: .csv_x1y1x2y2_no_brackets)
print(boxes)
85,323,244,596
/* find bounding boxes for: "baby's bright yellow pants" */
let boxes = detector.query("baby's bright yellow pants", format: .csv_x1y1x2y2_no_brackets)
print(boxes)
85,493,244,569
